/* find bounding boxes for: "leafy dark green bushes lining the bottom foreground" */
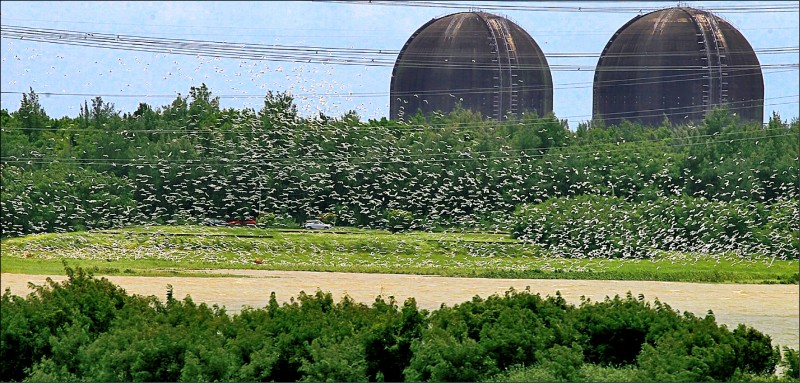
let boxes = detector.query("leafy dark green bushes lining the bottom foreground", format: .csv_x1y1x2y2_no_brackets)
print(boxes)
0,267,800,382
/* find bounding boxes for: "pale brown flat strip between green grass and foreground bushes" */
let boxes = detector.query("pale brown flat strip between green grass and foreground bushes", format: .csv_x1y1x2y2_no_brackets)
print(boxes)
0,270,800,349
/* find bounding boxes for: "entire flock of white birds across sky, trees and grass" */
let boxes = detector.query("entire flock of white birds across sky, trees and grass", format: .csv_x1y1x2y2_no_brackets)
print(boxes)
2,4,798,267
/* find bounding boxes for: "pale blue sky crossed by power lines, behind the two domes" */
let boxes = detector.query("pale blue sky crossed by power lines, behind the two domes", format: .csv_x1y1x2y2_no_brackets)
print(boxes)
0,1,800,129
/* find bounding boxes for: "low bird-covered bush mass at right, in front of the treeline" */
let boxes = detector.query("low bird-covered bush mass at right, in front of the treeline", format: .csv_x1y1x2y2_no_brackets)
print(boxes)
511,195,800,259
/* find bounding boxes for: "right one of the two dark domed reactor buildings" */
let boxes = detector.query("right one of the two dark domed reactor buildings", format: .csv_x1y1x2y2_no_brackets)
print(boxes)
592,8,764,126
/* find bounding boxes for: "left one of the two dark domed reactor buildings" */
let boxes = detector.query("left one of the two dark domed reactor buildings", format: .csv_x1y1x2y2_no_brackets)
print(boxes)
389,12,553,120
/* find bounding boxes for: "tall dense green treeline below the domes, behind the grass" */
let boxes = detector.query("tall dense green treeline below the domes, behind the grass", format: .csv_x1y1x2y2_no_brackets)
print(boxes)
0,85,800,246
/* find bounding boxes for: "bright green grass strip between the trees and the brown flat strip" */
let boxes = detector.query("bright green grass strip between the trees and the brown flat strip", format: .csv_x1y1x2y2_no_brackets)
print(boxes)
0,226,798,283
